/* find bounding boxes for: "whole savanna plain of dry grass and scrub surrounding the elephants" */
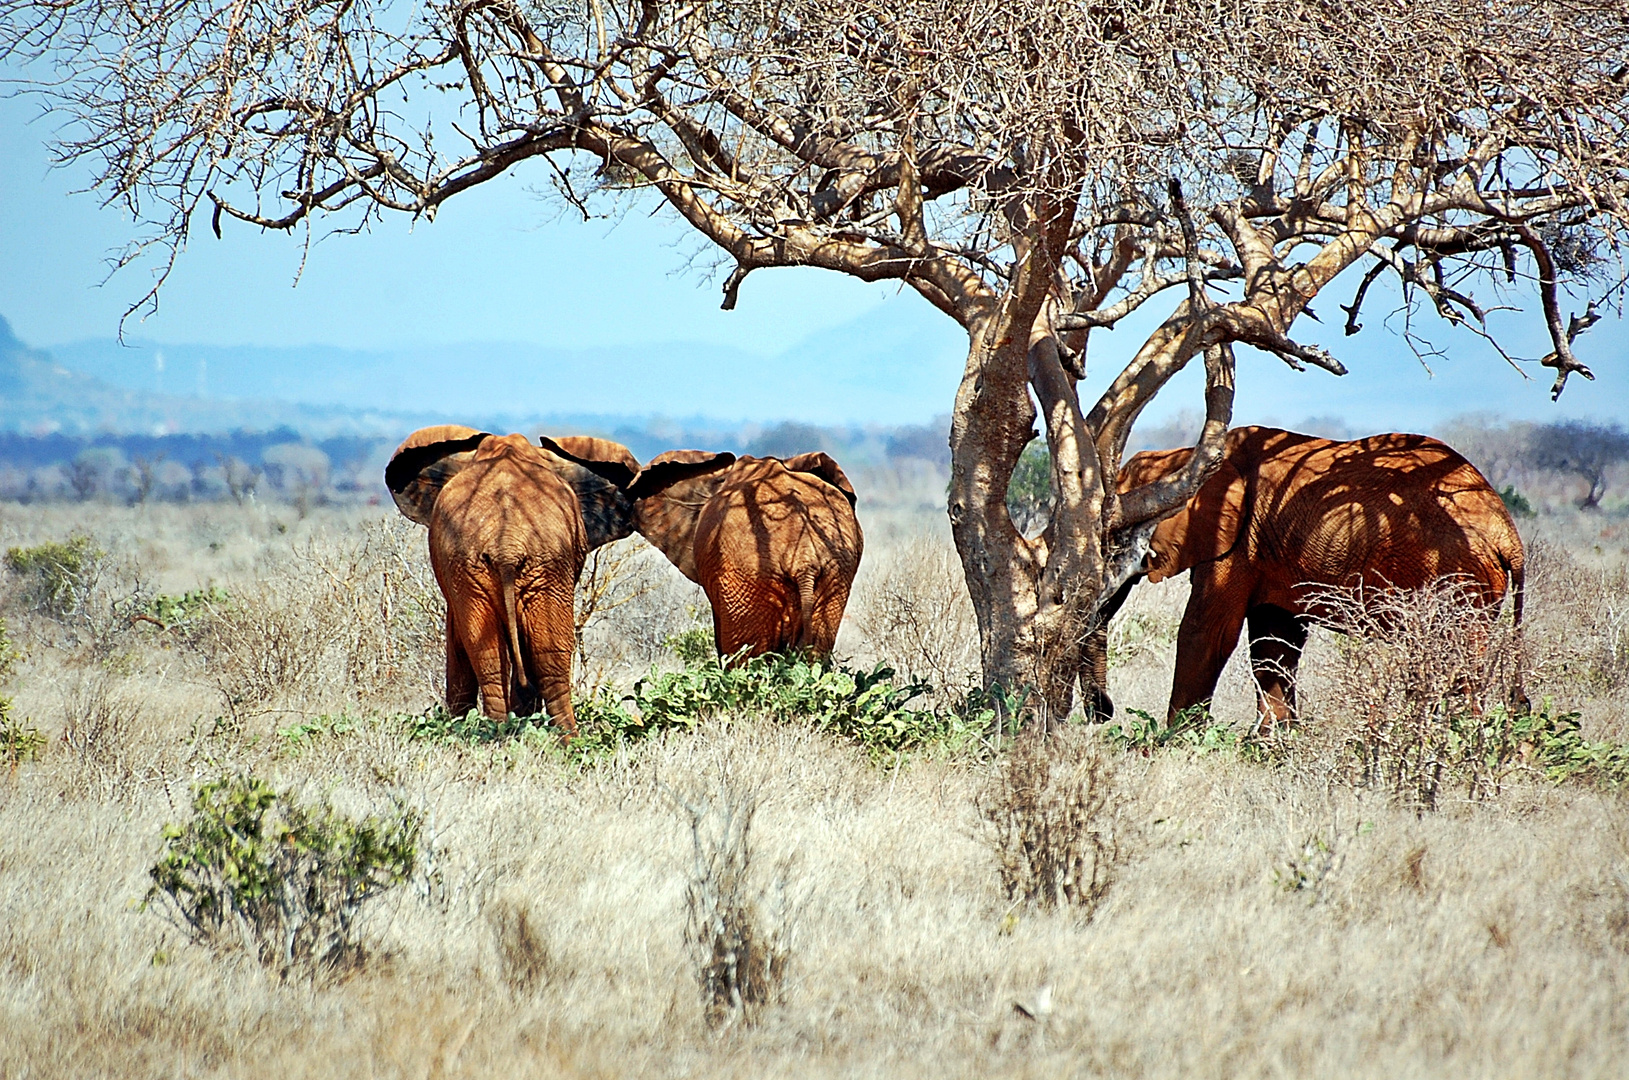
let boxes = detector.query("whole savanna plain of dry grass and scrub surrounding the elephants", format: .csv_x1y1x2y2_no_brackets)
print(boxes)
0,472,1629,1078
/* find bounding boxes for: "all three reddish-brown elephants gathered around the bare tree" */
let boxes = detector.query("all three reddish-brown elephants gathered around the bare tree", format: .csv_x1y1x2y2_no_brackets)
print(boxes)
384,425,1523,736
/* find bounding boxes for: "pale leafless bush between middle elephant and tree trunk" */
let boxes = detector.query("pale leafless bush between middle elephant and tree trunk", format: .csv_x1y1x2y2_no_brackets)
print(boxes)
854,536,979,694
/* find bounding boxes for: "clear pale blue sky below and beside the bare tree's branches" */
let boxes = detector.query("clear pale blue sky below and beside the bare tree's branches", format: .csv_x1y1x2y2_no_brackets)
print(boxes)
0,85,1629,430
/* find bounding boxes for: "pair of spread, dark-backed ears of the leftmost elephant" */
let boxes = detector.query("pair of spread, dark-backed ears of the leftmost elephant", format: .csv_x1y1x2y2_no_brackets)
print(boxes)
384,424,639,549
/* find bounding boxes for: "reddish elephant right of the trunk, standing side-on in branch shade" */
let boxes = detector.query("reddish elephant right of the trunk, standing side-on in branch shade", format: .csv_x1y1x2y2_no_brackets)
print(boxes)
1082,427,1525,725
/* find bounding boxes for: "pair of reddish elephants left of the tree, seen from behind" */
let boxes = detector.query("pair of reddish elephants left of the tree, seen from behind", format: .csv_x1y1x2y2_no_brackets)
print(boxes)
384,425,863,736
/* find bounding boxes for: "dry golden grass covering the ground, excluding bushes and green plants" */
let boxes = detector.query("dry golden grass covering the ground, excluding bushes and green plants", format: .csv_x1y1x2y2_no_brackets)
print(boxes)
0,507,1629,1078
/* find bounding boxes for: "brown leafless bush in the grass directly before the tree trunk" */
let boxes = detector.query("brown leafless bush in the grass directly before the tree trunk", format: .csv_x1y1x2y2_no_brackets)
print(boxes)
977,728,1126,919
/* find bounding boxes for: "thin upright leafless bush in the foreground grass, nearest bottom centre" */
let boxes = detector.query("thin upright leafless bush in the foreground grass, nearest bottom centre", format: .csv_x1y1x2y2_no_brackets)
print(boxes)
683,779,790,1028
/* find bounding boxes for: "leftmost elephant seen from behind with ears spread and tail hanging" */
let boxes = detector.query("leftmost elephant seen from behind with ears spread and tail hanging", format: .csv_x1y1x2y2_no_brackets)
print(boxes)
384,425,639,738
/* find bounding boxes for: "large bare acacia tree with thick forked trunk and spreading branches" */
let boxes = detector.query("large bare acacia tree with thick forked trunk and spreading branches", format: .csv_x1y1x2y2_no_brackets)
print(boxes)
0,0,1629,712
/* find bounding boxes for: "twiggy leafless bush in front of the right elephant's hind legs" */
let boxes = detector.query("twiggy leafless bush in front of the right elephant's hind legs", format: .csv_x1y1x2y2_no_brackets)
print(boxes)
1313,578,1521,810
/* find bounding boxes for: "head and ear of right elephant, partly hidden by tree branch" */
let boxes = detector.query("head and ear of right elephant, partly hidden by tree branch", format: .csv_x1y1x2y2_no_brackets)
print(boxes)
1116,448,1248,586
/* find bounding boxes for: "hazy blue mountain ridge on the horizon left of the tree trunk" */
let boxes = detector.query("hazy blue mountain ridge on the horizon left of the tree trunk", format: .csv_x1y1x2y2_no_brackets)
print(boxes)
52,305,966,425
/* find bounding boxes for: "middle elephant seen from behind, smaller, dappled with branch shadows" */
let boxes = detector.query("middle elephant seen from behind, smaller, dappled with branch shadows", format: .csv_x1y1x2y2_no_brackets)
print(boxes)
629,450,865,656
